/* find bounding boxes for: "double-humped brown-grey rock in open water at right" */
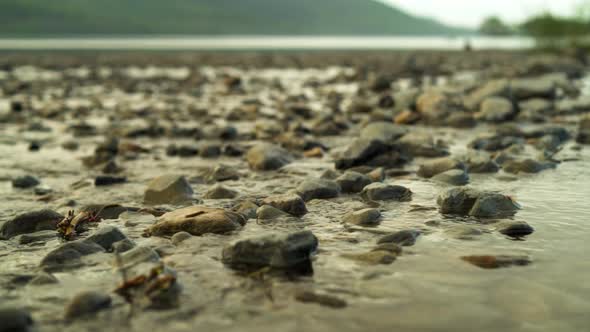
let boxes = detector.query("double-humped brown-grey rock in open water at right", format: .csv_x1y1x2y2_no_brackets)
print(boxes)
437,188,520,218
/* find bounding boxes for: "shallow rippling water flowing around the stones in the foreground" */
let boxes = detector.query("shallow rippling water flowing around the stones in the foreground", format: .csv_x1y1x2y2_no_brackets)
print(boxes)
0,63,590,331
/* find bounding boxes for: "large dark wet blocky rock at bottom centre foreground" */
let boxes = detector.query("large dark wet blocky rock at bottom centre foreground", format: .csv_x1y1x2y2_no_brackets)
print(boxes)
222,231,318,274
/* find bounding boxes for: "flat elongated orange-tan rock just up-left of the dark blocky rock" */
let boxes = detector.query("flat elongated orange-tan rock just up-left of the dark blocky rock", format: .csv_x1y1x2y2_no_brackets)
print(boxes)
147,206,246,236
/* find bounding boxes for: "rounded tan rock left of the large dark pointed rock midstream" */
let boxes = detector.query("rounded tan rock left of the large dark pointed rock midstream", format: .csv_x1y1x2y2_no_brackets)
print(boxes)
246,143,293,171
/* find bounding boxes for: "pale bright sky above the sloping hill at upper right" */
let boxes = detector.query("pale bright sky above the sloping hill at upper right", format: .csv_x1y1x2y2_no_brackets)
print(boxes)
381,0,582,27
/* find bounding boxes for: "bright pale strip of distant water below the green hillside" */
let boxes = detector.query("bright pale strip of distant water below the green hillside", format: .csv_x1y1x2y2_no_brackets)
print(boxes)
0,36,534,50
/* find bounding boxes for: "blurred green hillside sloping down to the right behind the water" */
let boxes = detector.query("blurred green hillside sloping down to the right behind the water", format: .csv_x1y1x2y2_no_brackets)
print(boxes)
0,0,466,36
